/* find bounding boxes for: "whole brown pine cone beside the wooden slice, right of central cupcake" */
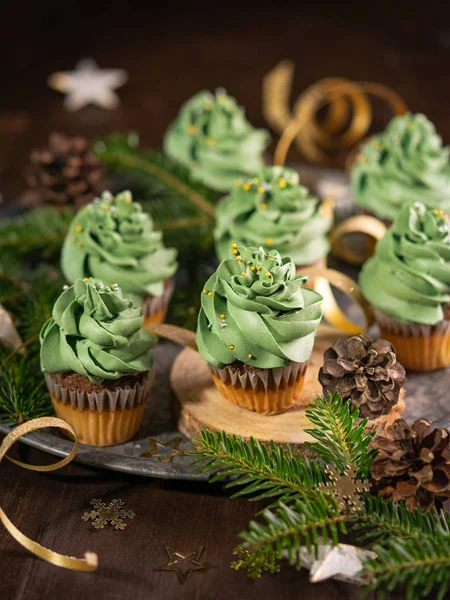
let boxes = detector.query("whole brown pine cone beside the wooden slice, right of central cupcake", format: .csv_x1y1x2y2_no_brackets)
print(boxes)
319,335,405,419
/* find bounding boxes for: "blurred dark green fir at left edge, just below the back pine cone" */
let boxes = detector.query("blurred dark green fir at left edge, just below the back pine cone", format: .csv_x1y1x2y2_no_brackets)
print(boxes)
0,206,73,264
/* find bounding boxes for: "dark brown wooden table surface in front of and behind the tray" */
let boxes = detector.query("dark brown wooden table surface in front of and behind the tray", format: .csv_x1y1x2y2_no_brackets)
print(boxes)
0,1,450,600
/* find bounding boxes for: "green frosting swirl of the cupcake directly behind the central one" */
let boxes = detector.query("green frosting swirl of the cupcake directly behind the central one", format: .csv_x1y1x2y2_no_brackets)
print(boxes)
214,166,332,272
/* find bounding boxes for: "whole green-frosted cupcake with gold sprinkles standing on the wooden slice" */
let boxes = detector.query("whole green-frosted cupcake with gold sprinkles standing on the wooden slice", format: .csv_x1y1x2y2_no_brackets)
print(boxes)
197,246,322,415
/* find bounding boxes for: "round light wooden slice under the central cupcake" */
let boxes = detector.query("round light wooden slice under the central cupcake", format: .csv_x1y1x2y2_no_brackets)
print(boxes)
170,325,342,446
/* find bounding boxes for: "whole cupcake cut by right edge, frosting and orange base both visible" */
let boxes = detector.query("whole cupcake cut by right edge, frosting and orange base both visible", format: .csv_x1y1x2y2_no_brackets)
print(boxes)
360,202,450,371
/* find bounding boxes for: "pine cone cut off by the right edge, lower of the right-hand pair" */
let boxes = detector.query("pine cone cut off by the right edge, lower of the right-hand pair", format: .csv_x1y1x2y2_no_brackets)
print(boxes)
371,419,450,510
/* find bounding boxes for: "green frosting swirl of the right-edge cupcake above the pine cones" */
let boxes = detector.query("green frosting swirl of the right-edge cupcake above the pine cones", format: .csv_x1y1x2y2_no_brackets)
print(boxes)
360,202,450,325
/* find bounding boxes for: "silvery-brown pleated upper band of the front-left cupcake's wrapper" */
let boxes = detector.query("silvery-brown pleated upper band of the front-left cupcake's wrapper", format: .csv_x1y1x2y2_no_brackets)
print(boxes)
45,370,153,413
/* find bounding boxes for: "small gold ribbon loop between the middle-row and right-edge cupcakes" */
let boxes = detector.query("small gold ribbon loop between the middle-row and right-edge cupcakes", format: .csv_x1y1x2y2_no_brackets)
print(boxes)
330,215,387,265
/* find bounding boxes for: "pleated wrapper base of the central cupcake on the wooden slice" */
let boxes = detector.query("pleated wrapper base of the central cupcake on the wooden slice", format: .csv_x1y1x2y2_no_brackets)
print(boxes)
212,362,307,415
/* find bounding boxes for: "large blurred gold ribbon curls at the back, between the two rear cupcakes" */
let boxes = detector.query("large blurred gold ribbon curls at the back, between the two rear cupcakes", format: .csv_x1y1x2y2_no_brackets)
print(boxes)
263,61,407,165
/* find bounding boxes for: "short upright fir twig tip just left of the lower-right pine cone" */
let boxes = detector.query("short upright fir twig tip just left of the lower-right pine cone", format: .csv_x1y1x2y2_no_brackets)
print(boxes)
305,393,376,478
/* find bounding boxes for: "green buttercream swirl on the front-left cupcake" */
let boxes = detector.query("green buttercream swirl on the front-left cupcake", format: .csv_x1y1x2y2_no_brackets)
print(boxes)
40,278,155,383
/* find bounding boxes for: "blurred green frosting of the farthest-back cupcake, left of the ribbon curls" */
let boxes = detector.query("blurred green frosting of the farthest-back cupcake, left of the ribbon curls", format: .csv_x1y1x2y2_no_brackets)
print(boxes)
164,88,270,192
